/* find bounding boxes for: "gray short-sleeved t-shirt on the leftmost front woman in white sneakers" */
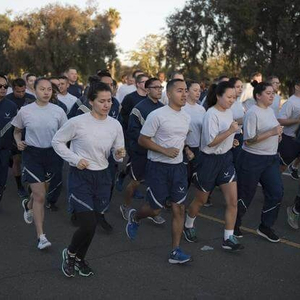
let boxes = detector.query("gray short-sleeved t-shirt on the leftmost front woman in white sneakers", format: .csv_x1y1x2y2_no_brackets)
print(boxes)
11,102,68,148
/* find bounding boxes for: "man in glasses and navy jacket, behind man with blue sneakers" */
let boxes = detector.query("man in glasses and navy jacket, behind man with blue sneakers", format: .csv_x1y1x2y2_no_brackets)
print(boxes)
120,78,165,224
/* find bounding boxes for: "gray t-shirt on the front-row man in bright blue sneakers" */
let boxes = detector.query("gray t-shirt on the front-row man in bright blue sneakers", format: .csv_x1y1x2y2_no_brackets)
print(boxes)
141,105,191,164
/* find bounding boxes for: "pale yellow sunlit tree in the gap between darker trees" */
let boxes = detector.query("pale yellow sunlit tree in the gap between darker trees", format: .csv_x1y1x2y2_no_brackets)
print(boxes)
129,34,166,76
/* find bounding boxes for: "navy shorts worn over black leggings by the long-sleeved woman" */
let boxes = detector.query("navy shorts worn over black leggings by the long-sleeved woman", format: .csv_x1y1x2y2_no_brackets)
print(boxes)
68,167,112,213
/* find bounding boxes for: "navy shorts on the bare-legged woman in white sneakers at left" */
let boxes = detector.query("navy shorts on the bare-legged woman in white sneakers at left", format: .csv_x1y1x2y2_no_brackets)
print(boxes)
22,146,63,183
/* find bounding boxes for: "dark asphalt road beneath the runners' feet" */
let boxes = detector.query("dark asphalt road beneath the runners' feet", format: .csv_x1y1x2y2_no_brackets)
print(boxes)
0,168,300,299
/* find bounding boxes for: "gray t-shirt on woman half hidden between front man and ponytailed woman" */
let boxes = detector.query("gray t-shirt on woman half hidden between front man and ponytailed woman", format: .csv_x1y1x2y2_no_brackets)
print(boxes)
182,102,206,147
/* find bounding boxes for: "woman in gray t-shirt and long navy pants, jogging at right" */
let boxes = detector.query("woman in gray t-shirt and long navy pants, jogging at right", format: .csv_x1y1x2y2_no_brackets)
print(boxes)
234,82,283,243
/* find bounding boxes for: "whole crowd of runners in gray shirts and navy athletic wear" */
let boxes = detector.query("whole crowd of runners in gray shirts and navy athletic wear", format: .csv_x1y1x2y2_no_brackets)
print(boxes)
0,68,300,277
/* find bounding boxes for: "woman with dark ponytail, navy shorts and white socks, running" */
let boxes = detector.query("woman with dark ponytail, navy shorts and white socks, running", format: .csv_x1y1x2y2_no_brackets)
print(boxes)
184,81,243,251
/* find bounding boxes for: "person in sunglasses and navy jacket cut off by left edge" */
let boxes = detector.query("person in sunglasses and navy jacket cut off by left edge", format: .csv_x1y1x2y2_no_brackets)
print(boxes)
0,75,18,201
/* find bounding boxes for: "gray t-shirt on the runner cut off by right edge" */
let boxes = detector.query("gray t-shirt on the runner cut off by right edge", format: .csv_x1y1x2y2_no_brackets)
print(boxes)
278,95,300,137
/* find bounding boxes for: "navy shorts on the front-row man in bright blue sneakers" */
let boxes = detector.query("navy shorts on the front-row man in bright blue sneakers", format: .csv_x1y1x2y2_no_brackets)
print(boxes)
146,160,188,209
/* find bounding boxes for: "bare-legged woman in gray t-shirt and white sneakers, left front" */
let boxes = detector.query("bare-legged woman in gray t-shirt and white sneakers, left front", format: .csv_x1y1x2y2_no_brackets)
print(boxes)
12,78,67,250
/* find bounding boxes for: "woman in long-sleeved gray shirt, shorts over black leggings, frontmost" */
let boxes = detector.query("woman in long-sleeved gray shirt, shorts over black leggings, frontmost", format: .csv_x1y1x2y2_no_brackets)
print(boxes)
52,83,125,277
